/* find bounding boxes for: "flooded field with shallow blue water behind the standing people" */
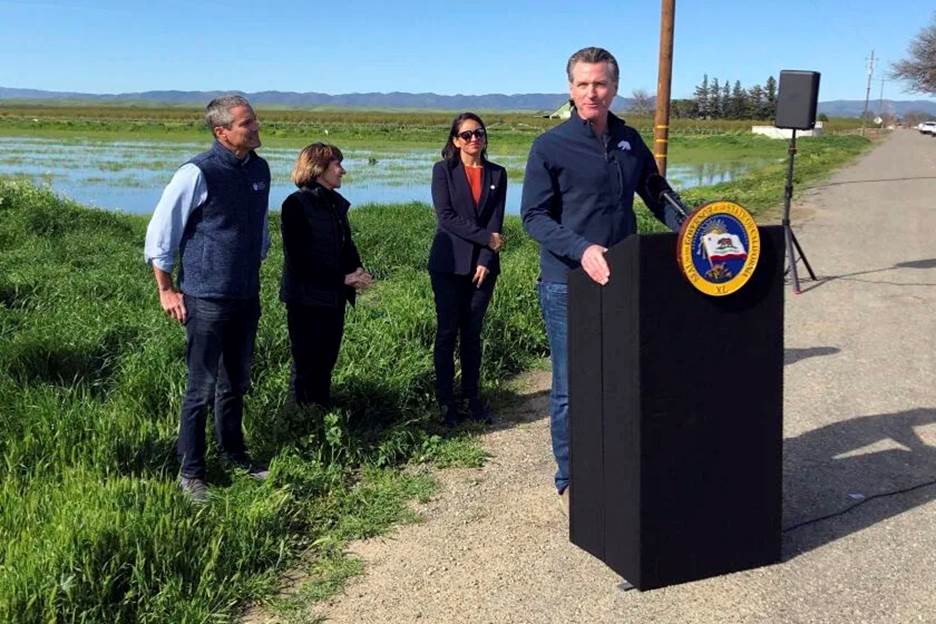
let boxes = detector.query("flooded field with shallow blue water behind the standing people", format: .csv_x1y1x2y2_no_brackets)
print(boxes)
0,137,770,214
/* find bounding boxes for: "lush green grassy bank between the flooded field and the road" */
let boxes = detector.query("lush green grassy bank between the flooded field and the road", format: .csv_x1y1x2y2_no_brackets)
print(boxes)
0,129,868,622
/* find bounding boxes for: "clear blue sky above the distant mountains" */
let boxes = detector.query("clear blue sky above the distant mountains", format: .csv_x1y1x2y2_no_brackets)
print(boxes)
0,0,934,100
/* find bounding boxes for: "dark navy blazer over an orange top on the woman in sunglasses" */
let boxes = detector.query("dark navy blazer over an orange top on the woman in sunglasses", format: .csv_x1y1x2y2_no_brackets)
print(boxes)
429,158,507,275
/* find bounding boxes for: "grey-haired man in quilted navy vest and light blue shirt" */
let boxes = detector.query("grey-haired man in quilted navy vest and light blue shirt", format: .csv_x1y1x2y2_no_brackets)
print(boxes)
144,95,270,502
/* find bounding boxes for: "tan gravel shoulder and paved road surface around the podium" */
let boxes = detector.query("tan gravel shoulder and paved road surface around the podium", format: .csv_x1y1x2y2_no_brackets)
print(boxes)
288,131,936,623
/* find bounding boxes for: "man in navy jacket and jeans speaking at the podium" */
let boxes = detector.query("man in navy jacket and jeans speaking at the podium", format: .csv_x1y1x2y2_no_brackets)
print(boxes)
520,47,678,511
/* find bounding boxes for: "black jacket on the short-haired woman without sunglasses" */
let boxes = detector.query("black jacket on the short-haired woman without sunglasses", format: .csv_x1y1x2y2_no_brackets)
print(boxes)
280,182,361,306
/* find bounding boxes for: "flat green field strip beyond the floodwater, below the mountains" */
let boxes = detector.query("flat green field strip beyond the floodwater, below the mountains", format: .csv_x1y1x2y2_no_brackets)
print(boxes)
0,102,860,155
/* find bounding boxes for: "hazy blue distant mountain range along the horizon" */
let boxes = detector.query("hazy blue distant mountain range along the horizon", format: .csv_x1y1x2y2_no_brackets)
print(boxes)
0,87,936,117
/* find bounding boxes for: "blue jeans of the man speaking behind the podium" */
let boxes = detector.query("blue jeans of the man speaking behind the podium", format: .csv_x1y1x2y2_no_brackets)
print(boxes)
538,282,569,492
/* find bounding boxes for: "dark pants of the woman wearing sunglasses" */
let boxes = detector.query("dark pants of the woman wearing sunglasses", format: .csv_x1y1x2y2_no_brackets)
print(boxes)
429,272,496,404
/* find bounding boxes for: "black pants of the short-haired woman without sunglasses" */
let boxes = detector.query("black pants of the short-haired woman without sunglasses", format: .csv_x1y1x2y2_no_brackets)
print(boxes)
286,302,345,406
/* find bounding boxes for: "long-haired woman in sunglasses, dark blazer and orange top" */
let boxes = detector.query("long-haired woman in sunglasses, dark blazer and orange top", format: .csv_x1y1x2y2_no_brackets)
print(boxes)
429,113,507,427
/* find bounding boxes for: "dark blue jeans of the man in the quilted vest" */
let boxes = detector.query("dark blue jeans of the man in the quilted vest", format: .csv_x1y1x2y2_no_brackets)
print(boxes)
176,295,260,478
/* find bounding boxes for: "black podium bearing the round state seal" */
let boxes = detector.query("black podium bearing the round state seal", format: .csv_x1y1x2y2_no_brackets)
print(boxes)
569,226,784,590
